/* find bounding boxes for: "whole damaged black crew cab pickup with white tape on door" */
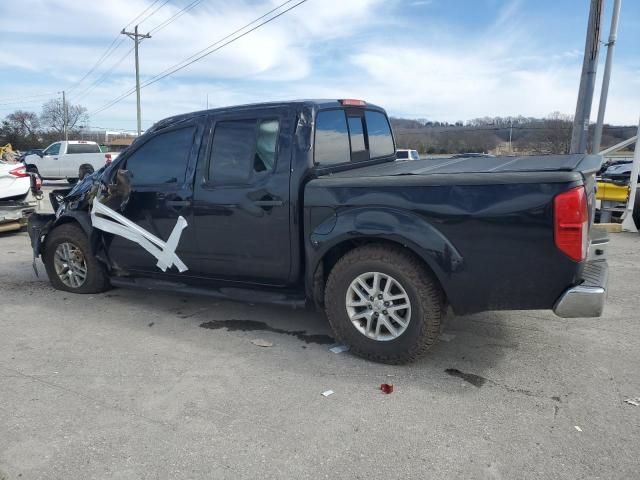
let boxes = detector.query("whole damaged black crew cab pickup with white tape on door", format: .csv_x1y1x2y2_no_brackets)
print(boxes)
29,100,607,363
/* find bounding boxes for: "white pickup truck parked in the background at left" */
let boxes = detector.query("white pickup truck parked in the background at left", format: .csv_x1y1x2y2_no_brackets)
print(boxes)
24,140,118,183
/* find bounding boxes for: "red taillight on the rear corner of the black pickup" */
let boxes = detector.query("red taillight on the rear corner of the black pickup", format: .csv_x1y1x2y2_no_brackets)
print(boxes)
553,187,589,262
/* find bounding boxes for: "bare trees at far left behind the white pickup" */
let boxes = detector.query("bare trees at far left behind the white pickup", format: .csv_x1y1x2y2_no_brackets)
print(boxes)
0,99,88,150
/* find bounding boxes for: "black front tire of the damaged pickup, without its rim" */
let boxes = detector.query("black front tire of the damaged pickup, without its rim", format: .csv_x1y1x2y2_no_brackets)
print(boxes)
43,223,110,293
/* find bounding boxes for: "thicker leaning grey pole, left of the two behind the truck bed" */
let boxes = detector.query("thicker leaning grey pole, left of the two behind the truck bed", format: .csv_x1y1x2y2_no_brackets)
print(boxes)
571,0,603,153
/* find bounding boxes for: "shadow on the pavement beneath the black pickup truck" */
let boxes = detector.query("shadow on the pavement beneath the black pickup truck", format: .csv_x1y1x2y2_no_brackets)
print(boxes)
97,289,533,387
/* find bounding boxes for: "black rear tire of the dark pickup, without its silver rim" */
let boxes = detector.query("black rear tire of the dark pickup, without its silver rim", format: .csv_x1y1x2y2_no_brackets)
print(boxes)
325,245,445,364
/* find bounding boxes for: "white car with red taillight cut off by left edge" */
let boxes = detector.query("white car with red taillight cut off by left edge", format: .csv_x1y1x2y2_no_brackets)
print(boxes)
0,161,40,232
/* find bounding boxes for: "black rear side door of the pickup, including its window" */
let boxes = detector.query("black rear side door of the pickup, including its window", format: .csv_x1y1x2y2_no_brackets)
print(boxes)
193,108,294,285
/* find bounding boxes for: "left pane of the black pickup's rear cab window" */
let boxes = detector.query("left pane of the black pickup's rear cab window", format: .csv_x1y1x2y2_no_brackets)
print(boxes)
315,110,351,166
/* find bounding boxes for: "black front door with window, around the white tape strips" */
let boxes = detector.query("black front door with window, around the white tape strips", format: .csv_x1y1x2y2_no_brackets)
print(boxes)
108,120,204,276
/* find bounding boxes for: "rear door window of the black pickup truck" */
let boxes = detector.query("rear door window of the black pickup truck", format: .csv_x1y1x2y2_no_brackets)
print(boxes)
208,119,280,185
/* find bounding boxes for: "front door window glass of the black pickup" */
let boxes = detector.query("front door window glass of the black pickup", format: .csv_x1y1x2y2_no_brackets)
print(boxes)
127,127,195,185
